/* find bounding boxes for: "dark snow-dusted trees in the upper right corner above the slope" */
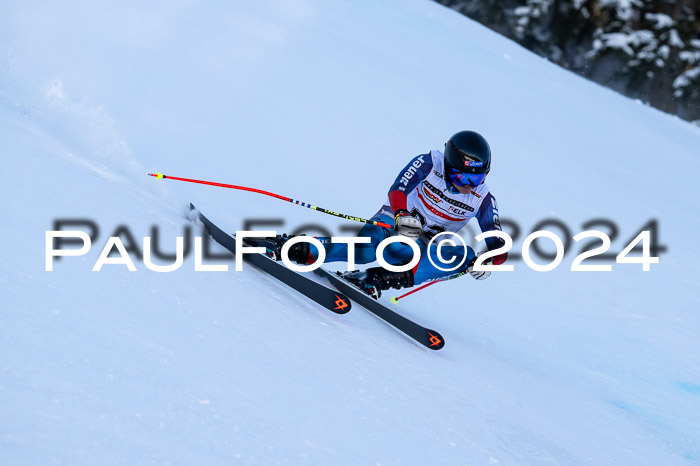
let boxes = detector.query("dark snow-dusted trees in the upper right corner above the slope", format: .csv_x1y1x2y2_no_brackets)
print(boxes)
436,0,700,121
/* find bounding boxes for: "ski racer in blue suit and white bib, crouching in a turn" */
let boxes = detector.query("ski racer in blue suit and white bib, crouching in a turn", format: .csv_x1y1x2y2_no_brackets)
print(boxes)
272,131,507,297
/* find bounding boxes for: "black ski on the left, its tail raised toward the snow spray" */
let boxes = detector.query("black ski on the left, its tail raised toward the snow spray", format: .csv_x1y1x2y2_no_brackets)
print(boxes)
190,203,352,314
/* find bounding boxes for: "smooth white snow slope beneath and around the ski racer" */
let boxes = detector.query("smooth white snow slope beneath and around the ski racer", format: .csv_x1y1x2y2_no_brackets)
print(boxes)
0,0,700,465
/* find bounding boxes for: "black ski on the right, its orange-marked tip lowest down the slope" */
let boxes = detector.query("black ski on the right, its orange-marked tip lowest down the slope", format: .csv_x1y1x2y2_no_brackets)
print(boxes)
314,268,445,350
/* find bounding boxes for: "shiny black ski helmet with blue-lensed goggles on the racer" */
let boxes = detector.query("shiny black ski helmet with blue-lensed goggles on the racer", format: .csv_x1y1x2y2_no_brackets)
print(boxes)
445,131,491,179
